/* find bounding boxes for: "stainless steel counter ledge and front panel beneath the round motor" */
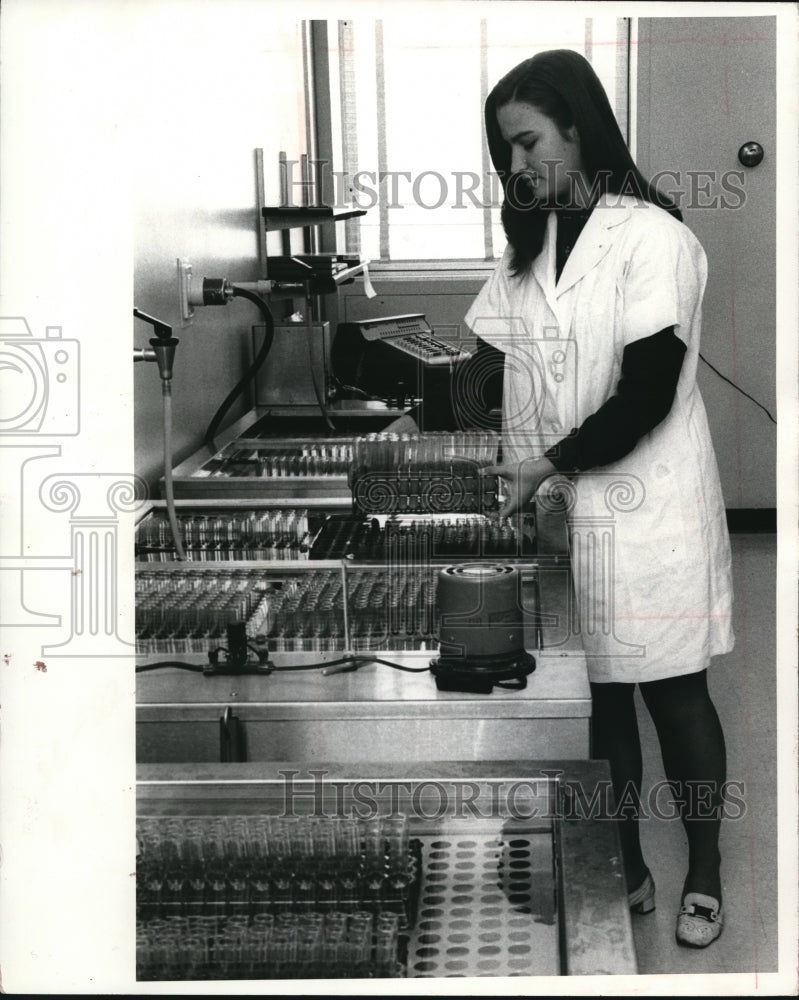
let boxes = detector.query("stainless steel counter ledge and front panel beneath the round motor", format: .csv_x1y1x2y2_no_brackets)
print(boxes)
137,650,591,763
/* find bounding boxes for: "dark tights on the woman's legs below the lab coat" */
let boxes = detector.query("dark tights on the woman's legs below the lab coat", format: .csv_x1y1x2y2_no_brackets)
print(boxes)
591,670,726,900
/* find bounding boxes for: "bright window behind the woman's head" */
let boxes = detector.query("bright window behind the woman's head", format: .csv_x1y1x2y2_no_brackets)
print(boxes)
328,15,628,262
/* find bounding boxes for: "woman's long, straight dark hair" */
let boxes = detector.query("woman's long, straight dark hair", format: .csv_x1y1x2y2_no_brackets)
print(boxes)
485,49,682,274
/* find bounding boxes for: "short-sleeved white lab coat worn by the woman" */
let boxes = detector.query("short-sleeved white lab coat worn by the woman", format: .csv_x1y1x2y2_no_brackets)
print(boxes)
466,195,734,682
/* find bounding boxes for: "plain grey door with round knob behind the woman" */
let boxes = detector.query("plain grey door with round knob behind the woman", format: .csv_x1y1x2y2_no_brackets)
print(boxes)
636,17,777,508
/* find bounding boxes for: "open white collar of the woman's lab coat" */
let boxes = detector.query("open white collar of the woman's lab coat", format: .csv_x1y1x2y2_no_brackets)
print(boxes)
533,194,639,304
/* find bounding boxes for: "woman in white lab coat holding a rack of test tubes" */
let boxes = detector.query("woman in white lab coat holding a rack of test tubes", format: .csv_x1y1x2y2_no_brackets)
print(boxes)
404,51,733,947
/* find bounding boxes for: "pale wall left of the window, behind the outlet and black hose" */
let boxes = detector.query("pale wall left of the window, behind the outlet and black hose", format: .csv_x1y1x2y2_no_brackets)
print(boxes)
130,0,304,485
